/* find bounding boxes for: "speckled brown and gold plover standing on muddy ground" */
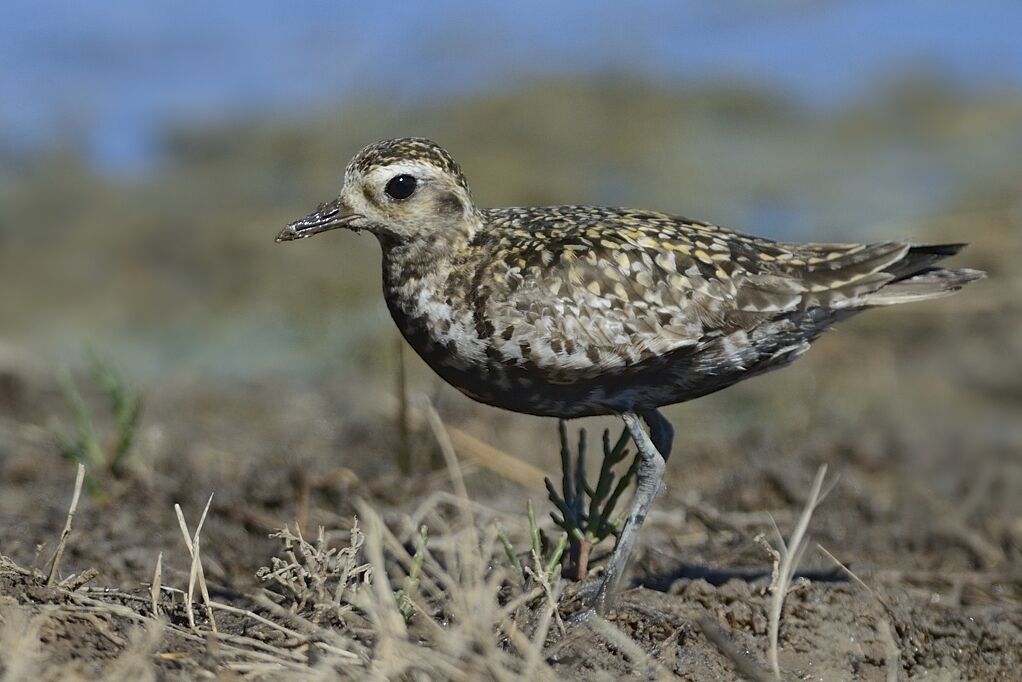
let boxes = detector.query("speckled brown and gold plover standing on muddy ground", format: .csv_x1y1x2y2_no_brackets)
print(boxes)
276,137,984,613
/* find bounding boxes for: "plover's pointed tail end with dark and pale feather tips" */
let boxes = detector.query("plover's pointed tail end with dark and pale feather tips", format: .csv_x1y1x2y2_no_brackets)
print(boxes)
863,244,986,306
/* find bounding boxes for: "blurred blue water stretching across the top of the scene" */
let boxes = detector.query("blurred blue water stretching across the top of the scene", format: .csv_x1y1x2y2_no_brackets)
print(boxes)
6,0,1022,171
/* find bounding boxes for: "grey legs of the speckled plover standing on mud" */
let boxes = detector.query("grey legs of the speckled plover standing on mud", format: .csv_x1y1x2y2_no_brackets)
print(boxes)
595,411,673,616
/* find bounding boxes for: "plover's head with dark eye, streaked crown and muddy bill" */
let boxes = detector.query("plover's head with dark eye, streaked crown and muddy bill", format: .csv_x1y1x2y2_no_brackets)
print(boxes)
277,137,475,242
